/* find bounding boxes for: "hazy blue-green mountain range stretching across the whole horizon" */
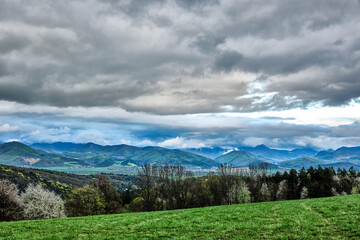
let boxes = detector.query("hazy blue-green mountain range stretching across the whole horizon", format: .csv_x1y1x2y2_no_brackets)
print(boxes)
0,142,360,169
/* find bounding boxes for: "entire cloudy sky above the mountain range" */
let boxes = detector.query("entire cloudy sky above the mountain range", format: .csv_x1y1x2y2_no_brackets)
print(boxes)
0,0,360,149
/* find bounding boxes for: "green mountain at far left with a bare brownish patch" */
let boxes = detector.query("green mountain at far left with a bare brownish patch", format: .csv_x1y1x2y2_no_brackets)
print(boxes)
0,142,86,167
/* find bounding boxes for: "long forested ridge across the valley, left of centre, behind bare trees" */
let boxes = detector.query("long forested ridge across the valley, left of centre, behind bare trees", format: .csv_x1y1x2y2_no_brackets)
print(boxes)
32,143,218,168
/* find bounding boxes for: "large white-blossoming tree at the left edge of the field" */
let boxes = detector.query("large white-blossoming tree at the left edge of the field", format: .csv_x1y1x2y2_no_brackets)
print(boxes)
21,184,66,219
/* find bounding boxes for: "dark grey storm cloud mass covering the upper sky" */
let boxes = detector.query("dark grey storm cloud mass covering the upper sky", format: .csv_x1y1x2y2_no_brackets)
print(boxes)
0,0,360,115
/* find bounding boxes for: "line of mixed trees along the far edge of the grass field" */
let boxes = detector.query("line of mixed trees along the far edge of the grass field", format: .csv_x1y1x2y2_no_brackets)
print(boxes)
0,164,360,221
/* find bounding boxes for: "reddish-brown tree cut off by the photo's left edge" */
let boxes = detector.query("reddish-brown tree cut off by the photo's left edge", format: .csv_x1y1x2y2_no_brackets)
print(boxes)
0,179,23,221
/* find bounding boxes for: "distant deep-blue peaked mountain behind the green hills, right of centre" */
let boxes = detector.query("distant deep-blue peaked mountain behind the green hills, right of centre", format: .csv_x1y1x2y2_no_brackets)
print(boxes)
239,144,317,163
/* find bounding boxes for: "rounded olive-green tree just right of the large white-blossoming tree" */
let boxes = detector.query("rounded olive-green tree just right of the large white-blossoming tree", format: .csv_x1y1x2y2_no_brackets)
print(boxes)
65,185,106,217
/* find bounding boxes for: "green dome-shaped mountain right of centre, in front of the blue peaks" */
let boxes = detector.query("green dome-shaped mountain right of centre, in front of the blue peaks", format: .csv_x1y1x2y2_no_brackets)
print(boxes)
215,150,274,167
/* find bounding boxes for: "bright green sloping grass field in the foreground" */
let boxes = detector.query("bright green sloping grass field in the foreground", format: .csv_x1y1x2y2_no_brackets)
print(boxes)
0,195,360,240
